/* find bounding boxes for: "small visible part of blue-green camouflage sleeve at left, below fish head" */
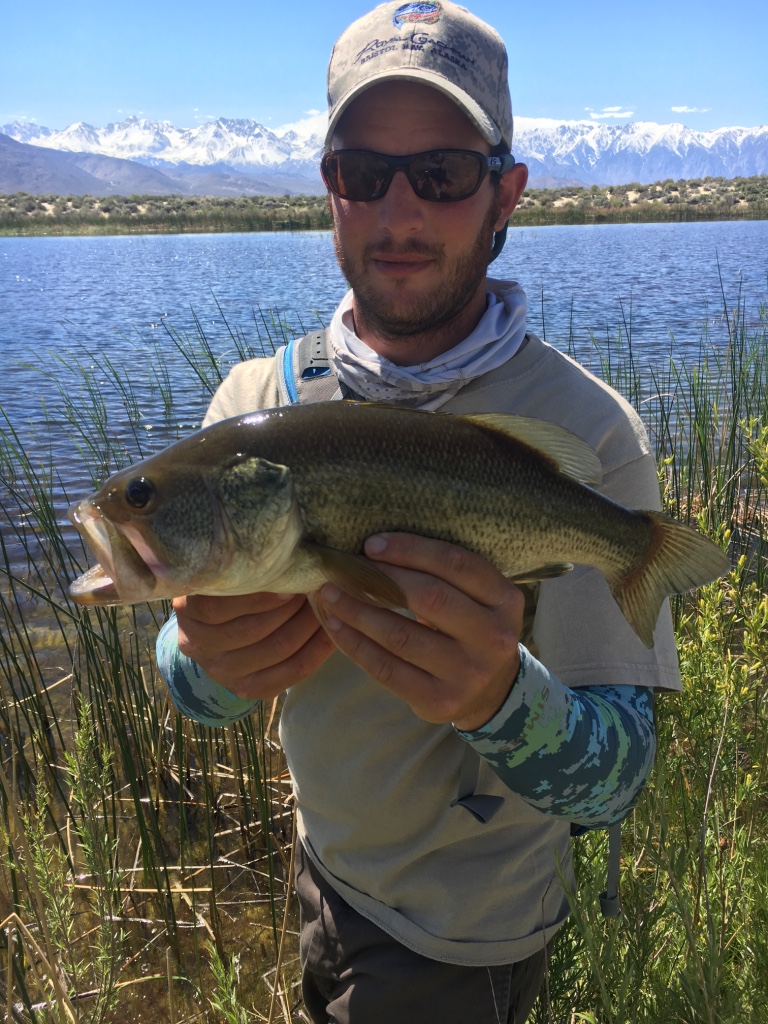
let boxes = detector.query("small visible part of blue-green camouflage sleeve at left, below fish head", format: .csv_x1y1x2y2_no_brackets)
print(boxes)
156,614,258,728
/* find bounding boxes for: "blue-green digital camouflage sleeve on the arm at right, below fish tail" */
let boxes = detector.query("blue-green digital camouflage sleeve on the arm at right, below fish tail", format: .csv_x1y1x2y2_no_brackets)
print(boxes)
459,646,656,828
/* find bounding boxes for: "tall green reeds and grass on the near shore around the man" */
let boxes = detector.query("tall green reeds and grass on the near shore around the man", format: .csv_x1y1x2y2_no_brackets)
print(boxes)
0,292,768,1024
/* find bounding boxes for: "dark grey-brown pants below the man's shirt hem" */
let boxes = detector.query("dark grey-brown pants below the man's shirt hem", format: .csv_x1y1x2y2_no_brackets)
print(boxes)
296,843,547,1024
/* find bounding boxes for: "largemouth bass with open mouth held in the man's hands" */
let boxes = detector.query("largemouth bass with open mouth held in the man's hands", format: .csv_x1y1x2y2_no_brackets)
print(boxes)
70,401,728,646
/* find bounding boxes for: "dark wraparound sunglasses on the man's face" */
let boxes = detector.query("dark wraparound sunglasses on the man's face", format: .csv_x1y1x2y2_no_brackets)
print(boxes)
321,150,515,203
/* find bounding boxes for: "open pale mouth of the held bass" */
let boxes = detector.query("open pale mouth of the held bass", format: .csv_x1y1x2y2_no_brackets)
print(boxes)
68,499,158,606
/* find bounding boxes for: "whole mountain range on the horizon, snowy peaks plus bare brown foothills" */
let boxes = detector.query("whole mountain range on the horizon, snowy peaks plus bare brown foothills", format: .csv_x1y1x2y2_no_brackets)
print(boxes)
0,114,768,196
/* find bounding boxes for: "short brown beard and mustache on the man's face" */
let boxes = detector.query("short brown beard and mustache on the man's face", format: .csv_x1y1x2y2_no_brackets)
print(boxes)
334,200,500,341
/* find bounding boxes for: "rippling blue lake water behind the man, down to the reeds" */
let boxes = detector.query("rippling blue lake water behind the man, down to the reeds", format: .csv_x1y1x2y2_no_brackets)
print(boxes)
0,221,768,507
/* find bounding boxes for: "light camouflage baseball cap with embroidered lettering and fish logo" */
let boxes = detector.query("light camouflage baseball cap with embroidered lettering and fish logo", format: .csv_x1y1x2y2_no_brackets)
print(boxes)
326,0,512,147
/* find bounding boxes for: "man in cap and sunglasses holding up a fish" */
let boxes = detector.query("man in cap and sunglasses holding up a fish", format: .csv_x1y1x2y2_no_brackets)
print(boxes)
159,0,680,1024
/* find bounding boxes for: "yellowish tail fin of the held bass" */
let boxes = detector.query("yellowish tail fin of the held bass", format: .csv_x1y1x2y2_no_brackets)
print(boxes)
608,511,729,647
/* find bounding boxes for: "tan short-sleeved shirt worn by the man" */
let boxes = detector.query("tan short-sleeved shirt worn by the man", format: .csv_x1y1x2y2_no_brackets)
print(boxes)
205,336,680,965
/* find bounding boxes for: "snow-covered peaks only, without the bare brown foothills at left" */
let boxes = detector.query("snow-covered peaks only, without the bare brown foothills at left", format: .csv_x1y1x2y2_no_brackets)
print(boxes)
0,113,768,195
